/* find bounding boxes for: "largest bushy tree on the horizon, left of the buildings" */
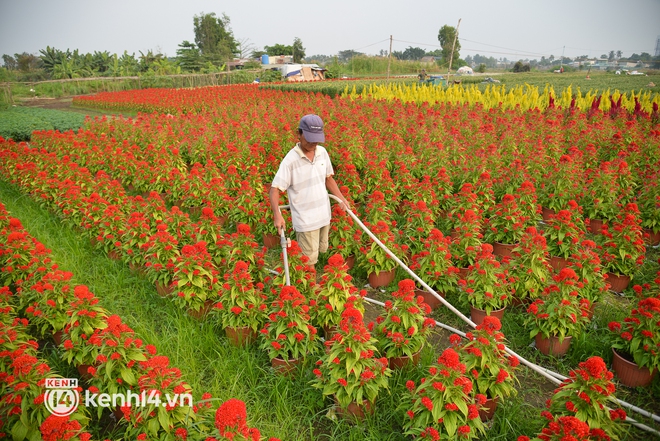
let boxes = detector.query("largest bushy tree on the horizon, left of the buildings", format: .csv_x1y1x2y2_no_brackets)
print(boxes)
193,12,238,65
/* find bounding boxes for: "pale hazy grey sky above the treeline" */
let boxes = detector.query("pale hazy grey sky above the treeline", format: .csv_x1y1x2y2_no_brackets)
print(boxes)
0,0,660,60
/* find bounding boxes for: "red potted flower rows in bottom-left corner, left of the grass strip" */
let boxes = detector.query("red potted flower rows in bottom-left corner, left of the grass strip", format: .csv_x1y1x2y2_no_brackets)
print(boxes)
0,206,274,440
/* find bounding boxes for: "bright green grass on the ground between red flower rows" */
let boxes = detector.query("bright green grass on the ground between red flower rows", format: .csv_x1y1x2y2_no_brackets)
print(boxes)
0,176,660,441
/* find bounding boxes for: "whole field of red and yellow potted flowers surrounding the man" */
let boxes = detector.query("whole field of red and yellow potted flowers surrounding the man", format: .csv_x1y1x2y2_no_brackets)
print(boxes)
0,85,660,440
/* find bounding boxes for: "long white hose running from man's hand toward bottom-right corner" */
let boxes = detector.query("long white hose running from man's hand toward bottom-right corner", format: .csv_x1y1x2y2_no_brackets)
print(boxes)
328,194,660,437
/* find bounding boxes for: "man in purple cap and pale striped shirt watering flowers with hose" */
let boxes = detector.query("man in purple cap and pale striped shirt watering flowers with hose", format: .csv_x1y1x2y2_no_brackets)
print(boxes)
270,114,348,266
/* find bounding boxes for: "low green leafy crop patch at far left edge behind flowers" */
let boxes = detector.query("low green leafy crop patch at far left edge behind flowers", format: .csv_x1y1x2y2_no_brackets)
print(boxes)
0,107,85,141
